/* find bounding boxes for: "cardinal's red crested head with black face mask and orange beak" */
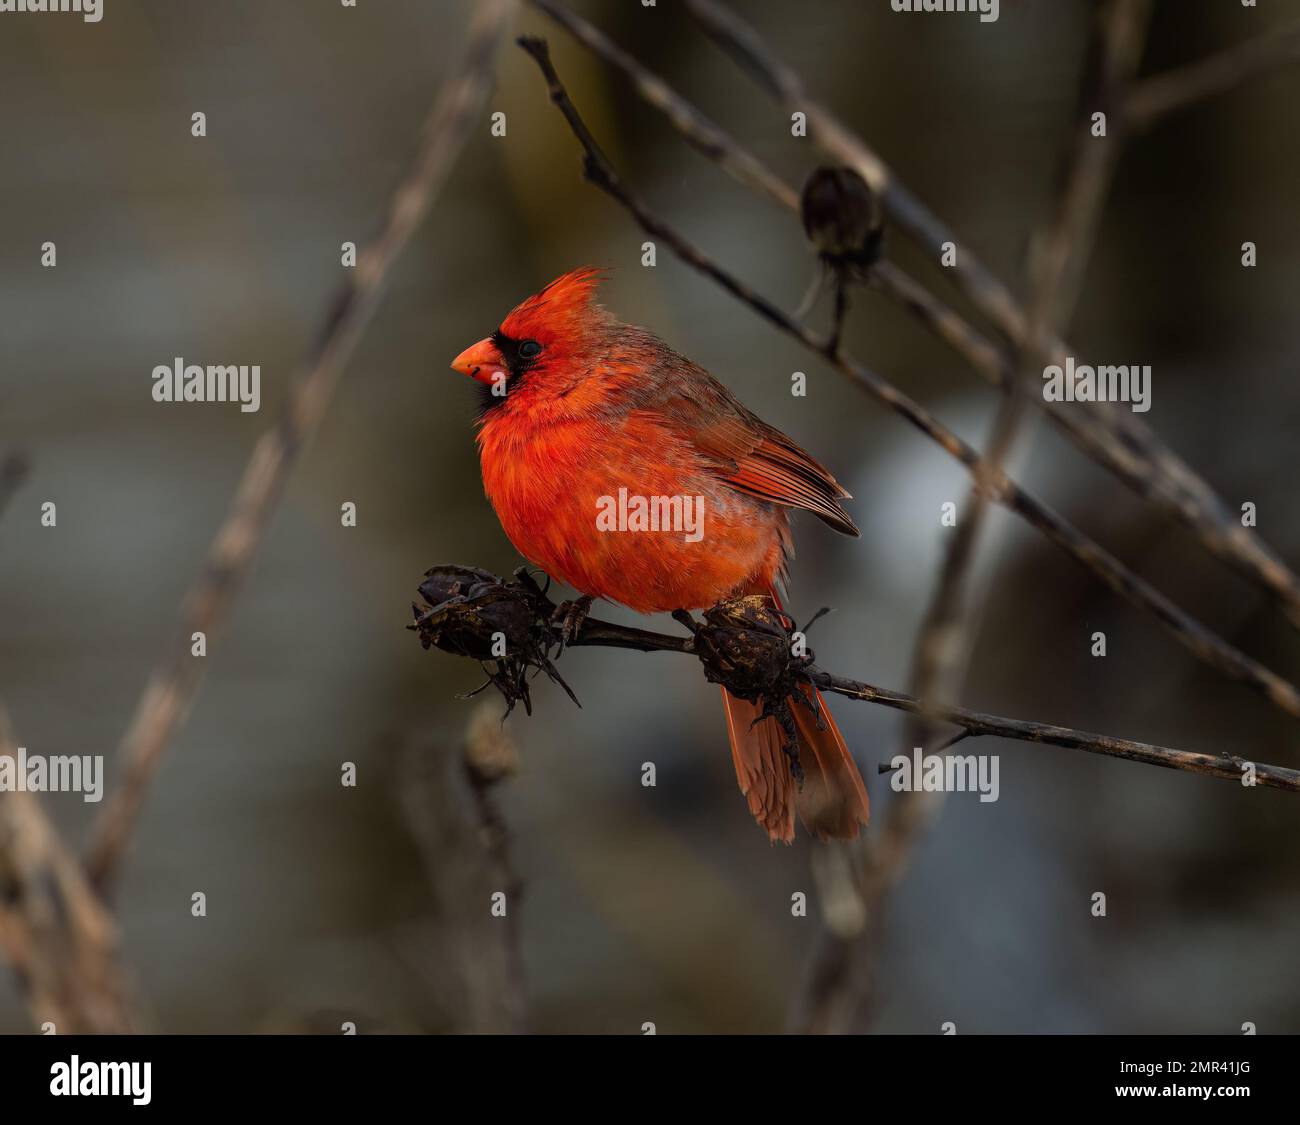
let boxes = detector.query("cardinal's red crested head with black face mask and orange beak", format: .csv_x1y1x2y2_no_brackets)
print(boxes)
451,265,614,407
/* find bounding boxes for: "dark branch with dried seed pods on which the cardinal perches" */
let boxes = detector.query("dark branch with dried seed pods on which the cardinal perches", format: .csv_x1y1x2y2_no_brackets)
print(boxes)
410,566,1300,793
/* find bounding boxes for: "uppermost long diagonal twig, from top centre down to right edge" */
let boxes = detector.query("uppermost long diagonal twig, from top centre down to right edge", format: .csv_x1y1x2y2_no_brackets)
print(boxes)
686,0,1300,628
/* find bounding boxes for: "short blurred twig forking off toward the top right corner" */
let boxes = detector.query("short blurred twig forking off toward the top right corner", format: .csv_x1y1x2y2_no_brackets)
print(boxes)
1125,21,1300,131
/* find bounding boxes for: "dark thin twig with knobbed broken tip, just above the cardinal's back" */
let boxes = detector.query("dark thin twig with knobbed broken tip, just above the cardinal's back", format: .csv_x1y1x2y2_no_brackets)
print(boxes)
520,38,1300,718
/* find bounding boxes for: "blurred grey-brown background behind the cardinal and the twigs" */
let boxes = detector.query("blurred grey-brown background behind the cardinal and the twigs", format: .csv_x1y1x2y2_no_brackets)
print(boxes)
0,0,1300,1033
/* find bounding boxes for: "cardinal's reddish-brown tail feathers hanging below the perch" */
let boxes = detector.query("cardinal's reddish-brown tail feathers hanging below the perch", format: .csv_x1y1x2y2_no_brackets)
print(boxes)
723,587,868,843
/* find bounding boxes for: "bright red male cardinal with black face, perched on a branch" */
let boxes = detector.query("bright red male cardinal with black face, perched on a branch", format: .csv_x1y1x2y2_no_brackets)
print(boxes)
451,267,867,843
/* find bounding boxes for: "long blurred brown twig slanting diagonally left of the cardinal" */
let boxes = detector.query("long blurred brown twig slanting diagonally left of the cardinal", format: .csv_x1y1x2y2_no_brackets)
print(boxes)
87,0,515,888
